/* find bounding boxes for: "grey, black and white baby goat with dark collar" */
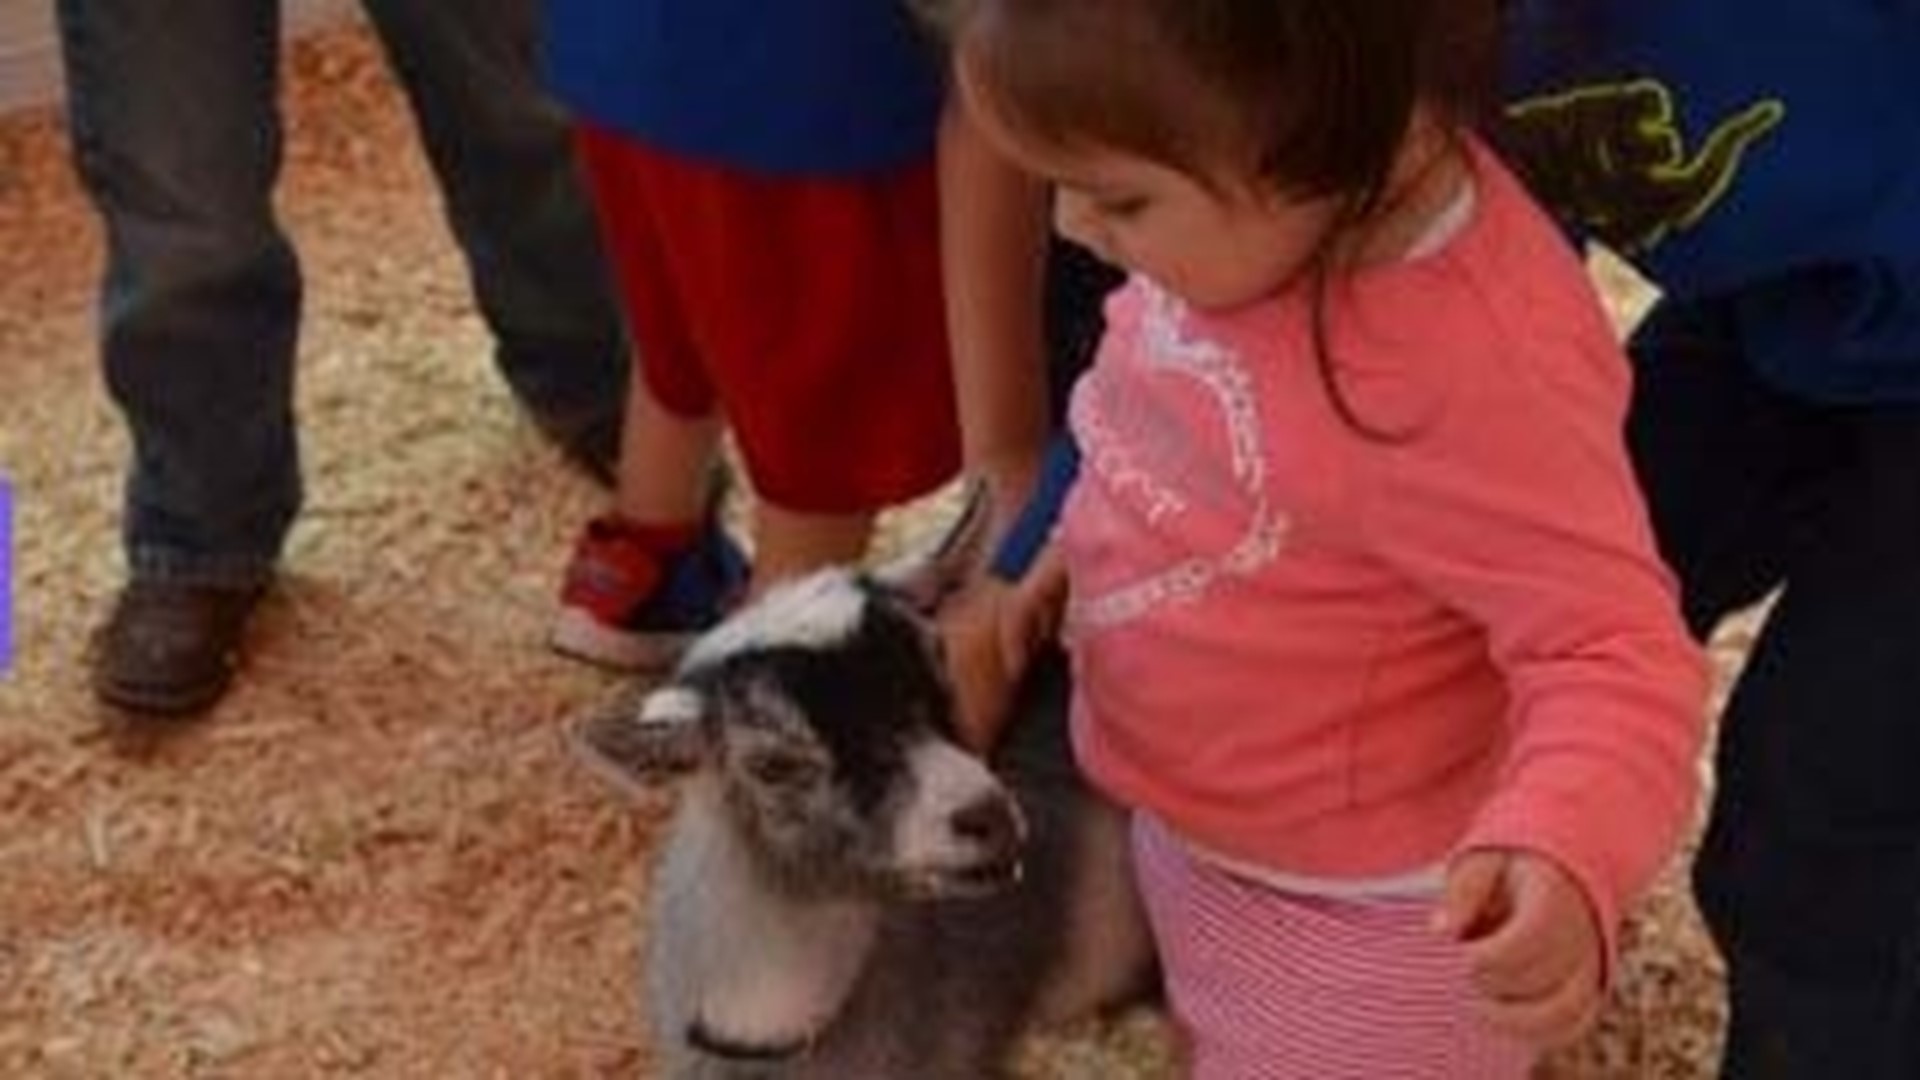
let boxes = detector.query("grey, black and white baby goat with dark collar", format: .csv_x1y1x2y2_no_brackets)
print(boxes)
576,571,1152,1080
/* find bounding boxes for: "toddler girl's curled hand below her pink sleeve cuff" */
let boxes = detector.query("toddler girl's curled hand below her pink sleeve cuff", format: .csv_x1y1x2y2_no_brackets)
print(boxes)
1434,849,1605,1045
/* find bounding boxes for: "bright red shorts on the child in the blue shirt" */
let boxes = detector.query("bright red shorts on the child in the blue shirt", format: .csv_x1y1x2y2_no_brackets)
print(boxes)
576,125,960,513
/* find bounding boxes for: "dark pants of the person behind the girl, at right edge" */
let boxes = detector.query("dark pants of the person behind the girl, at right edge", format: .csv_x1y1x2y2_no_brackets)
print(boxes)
1630,294,1920,1080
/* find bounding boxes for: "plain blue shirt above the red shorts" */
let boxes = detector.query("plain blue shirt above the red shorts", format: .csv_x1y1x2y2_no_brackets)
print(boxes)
545,0,945,177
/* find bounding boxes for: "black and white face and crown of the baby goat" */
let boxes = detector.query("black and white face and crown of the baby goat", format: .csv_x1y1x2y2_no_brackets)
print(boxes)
675,573,1025,896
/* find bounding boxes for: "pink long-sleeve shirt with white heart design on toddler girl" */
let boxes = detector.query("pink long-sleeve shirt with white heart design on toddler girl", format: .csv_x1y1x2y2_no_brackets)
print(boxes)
1060,154,1707,934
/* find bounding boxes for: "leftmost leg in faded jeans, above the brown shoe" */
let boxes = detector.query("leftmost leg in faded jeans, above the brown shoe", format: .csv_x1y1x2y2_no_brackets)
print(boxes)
58,0,300,584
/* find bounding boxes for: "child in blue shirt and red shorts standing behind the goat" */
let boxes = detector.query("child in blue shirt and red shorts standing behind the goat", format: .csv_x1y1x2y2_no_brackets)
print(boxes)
547,0,958,669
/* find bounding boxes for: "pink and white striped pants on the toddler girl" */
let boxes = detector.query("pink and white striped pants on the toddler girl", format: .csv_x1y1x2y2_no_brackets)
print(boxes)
1133,815,1534,1080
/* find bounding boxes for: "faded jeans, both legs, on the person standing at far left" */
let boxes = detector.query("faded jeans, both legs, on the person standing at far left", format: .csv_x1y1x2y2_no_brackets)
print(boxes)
58,0,628,584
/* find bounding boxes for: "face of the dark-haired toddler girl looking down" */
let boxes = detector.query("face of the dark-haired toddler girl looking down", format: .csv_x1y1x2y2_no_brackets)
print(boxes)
973,94,1336,311
